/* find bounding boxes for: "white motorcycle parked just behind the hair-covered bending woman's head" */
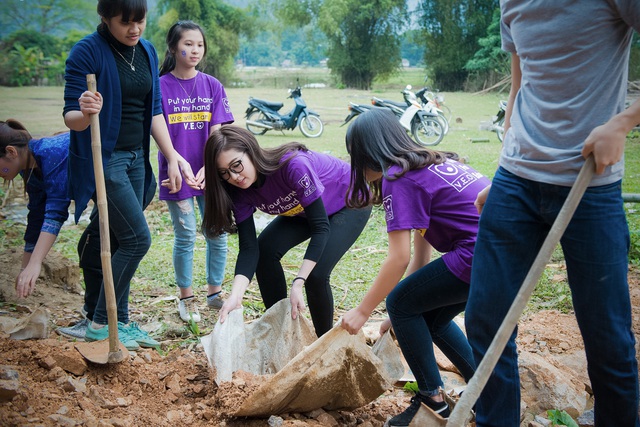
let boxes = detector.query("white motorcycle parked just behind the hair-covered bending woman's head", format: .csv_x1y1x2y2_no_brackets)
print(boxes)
371,90,445,146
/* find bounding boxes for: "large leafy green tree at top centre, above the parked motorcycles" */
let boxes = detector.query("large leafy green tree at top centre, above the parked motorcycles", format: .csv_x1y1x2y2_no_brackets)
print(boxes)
275,0,407,89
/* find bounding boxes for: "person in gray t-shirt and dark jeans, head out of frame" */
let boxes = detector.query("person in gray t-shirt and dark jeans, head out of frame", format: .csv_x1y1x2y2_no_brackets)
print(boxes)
465,0,640,427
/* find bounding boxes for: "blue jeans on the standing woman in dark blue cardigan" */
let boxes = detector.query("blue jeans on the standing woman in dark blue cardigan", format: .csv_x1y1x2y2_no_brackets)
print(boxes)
87,149,151,325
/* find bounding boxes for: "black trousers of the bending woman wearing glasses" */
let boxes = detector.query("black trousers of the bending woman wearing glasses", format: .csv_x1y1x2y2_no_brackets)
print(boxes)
256,207,371,336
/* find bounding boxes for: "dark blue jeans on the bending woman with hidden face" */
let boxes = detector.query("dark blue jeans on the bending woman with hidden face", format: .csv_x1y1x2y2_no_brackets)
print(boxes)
387,258,475,393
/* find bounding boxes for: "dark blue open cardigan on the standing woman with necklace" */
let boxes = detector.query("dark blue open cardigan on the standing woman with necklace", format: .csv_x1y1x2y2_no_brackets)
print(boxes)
63,32,162,223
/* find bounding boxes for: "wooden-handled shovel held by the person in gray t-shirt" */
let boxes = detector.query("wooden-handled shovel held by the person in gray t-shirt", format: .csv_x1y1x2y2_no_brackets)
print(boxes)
410,156,595,427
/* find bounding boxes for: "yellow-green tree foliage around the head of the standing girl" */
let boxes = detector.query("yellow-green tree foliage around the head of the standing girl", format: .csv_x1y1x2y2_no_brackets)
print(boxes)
149,0,250,83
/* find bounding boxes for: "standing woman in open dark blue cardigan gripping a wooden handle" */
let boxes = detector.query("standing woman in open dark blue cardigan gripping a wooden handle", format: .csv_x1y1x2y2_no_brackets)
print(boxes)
64,0,193,350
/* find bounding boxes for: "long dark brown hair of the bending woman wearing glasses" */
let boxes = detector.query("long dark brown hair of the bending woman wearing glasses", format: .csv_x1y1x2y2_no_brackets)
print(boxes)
202,125,308,237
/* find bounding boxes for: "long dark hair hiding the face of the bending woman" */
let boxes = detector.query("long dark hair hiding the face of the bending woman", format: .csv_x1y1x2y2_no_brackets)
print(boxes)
345,108,458,208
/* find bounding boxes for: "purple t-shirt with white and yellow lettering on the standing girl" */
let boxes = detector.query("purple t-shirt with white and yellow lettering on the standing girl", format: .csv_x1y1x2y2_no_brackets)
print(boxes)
158,72,234,200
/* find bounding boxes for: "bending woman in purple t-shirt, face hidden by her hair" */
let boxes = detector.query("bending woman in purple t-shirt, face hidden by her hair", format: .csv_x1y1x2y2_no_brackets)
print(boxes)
342,110,489,426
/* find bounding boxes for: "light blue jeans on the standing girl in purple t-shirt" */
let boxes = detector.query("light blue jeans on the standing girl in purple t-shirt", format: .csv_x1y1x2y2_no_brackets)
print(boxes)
166,196,227,288
